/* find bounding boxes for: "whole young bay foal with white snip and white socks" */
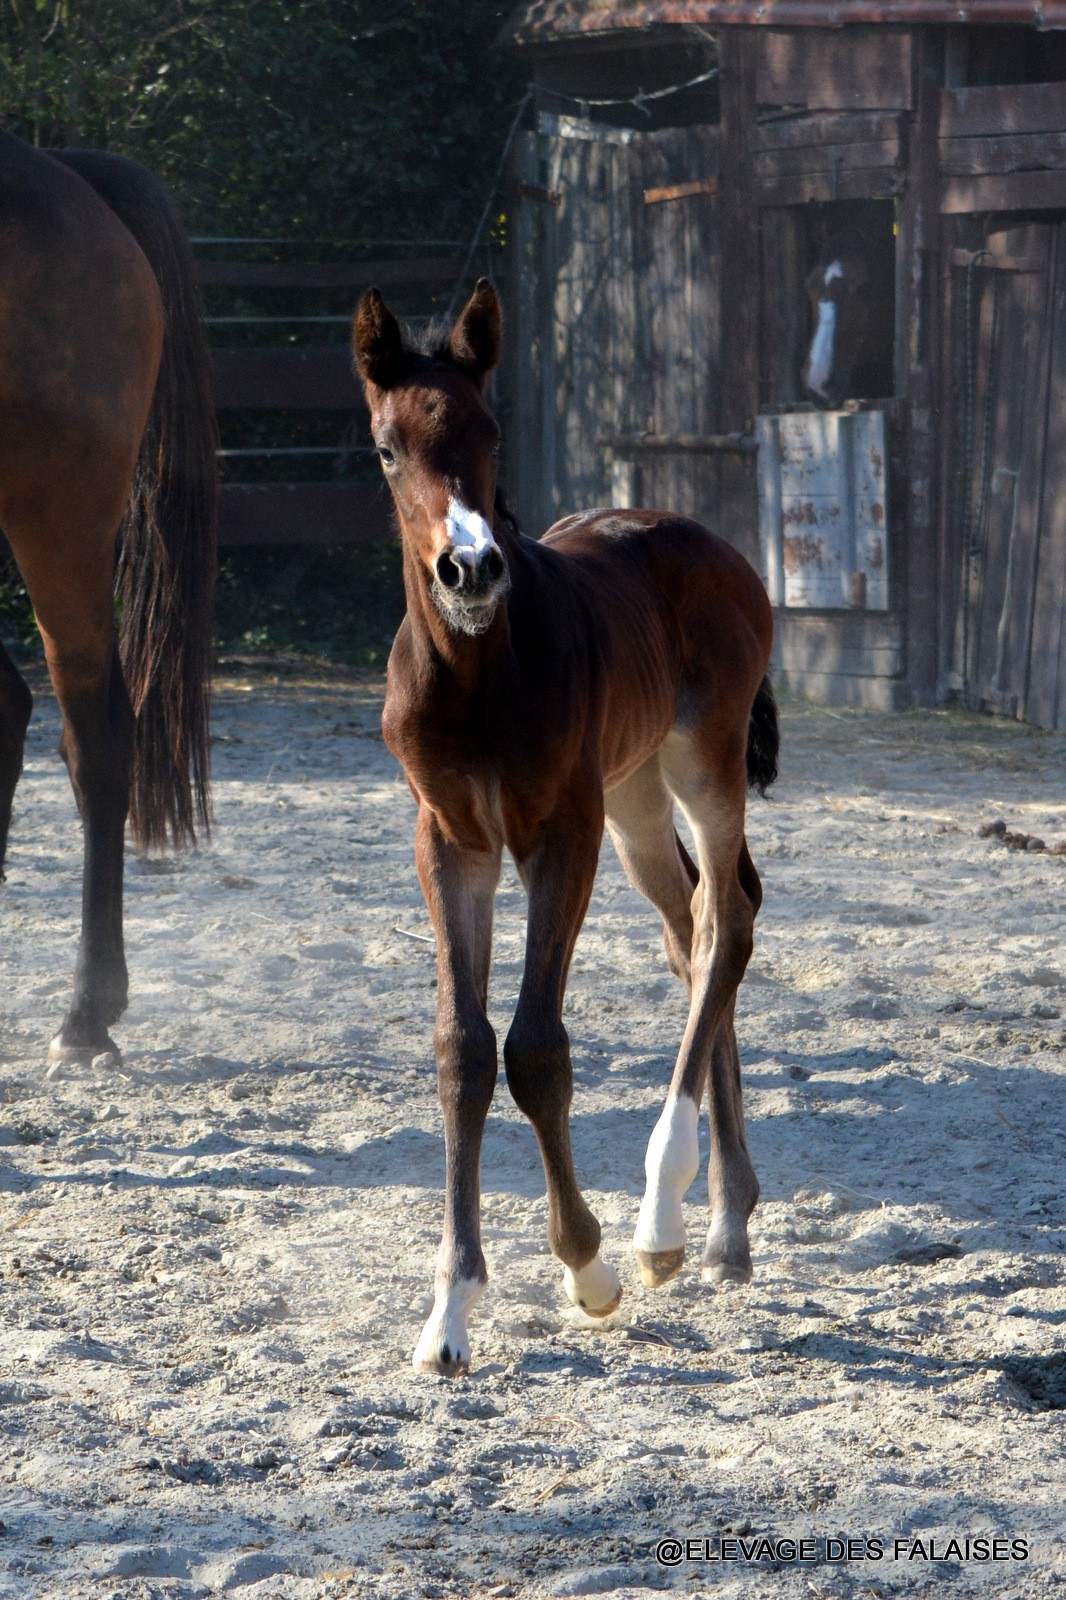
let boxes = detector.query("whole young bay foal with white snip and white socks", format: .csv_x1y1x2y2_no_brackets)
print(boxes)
354,280,778,1373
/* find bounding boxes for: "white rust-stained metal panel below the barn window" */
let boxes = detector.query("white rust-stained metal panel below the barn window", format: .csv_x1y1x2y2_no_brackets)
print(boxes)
757,411,888,611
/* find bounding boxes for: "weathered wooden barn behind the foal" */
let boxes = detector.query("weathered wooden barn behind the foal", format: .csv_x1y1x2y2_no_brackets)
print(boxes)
503,0,1066,728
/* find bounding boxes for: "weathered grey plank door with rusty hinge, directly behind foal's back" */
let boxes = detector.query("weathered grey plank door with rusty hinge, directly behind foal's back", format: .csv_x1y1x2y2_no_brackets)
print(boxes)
504,115,720,534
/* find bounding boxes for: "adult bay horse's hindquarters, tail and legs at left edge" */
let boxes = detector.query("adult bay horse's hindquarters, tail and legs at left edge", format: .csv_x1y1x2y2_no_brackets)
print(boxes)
0,133,214,1059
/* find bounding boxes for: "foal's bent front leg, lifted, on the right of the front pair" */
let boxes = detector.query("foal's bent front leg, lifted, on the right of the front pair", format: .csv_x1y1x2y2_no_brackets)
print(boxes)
504,806,621,1317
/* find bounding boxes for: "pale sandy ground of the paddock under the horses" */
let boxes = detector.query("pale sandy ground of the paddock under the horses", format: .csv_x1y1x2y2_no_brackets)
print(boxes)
0,674,1066,1600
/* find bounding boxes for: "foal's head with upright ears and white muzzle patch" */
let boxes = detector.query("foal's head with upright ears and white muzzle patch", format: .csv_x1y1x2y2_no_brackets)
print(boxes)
352,278,507,634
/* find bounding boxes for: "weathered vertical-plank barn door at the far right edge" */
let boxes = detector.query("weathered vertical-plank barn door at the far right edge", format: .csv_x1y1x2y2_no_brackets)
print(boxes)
948,222,1066,718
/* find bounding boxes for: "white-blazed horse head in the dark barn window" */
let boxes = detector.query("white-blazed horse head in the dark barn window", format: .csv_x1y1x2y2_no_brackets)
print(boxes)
804,230,895,406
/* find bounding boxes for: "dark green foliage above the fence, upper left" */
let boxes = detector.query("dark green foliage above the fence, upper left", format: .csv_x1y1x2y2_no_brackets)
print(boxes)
0,0,520,238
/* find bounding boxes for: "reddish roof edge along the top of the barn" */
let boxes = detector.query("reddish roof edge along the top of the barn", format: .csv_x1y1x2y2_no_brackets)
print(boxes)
504,0,1066,45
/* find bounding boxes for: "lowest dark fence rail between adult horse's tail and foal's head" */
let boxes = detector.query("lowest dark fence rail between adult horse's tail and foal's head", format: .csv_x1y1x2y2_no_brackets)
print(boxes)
218,482,392,544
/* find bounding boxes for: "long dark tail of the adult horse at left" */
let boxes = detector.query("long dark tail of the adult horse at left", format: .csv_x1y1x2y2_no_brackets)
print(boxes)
53,150,216,848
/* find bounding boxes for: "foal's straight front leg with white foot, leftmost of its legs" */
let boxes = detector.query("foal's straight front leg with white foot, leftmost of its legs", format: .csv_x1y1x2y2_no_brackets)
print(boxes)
413,806,501,1378
